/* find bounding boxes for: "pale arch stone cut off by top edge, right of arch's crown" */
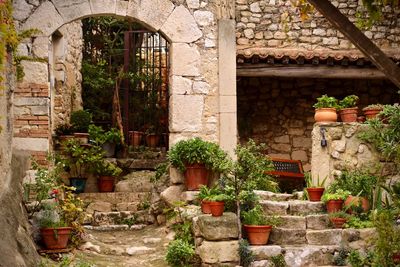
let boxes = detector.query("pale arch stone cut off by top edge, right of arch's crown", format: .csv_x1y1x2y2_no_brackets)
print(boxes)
127,0,174,30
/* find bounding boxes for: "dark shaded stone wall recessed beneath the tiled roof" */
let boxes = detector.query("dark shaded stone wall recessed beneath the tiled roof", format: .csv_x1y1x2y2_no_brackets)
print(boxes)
238,77,398,171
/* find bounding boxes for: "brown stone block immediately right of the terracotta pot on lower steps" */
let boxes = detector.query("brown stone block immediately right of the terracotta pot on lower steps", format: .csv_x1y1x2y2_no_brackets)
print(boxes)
269,227,307,245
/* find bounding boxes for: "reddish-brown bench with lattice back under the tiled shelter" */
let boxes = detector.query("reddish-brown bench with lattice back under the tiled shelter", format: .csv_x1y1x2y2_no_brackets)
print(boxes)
268,158,305,193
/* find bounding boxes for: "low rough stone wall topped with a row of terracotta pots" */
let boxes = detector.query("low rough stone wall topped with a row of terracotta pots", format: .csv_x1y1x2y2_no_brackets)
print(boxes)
311,123,394,185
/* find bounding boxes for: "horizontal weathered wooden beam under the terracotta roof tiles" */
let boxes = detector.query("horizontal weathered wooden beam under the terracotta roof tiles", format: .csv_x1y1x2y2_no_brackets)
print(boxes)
237,64,387,79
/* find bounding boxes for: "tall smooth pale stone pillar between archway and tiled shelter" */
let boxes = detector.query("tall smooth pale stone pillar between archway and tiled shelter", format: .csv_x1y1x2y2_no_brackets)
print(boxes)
218,19,237,157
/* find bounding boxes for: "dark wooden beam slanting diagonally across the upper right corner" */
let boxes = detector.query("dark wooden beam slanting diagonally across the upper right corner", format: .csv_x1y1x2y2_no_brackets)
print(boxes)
307,0,400,88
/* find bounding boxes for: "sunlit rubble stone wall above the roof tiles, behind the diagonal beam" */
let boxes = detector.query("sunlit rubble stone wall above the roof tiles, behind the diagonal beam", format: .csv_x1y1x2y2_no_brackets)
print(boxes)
236,0,400,50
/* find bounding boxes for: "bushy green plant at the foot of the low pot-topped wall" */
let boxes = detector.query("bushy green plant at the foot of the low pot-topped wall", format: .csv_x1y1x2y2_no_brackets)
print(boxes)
328,169,378,200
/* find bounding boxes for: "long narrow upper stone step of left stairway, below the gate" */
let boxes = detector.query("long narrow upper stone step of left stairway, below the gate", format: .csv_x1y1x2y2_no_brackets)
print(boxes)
79,192,149,205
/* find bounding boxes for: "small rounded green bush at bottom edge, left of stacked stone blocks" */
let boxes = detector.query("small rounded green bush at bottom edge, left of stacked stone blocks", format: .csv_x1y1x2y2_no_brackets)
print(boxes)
165,239,195,267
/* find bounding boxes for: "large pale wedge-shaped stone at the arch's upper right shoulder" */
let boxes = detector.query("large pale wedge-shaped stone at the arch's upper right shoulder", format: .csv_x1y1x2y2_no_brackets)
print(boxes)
161,5,203,43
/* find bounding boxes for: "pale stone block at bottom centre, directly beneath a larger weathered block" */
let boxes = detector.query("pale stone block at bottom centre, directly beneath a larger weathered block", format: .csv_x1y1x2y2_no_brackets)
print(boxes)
197,241,239,264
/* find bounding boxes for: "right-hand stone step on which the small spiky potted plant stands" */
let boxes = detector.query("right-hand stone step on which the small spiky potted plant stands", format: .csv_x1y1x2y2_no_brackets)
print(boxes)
260,200,325,215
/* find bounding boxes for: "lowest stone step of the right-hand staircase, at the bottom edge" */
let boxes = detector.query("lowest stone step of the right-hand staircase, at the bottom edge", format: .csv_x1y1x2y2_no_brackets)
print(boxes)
250,245,340,267
